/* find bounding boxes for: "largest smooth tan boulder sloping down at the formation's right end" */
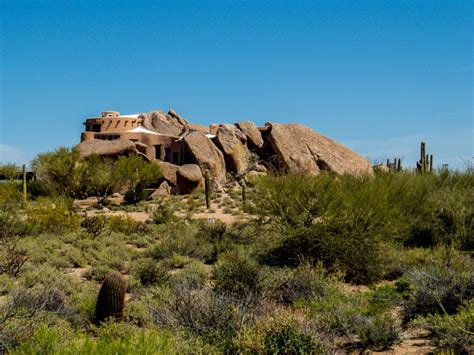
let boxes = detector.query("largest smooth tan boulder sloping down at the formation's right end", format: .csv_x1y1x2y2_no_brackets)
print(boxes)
265,123,373,175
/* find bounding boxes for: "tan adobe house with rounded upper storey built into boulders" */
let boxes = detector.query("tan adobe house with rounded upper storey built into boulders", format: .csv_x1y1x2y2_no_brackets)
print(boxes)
81,111,190,165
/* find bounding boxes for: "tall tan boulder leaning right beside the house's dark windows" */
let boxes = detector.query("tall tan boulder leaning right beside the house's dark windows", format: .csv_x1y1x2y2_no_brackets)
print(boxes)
183,131,226,183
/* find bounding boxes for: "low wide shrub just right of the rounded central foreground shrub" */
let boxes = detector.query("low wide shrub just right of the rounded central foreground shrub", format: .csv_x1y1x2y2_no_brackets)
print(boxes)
260,264,330,305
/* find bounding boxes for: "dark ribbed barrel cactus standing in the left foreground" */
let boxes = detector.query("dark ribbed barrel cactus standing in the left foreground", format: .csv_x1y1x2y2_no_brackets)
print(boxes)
95,271,127,324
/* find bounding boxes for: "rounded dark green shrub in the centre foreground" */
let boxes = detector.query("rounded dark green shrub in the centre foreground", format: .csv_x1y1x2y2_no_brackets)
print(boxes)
213,250,260,297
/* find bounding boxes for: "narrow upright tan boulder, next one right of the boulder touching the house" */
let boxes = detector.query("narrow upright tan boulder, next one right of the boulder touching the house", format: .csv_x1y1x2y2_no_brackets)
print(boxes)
215,125,251,175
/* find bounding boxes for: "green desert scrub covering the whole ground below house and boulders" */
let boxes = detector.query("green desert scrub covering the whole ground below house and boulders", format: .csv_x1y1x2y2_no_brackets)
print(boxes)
0,151,474,354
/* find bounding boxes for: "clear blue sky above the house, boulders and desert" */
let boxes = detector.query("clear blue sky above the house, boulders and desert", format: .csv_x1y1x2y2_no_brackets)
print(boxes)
0,0,474,168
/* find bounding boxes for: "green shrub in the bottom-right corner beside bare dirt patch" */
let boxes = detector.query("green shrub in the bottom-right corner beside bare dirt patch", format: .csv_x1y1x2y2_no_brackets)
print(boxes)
415,300,474,353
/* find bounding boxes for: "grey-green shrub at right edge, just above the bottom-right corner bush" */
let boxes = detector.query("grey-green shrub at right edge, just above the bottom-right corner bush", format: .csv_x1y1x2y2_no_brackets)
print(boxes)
403,255,474,320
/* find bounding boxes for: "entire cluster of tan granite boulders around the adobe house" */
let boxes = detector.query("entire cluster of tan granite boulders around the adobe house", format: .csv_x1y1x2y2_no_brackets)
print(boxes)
78,110,374,194
